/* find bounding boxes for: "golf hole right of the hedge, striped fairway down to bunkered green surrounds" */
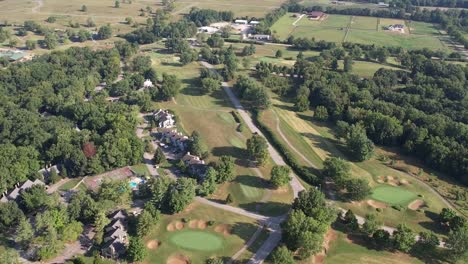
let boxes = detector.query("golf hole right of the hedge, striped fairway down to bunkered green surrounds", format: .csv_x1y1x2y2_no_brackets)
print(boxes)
262,97,452,231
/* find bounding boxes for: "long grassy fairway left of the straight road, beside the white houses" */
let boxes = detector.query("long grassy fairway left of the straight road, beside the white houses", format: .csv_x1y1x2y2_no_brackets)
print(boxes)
149,46,292,215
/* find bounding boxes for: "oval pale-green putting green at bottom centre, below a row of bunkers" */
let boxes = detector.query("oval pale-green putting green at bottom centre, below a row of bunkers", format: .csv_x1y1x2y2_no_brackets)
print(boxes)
169,230,224,251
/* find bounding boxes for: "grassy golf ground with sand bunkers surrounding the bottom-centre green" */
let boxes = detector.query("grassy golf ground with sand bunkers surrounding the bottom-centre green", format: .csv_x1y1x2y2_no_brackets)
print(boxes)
145,203,258,263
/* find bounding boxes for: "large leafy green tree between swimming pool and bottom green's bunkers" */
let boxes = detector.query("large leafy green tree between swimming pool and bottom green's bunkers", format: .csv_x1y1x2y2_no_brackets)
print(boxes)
167,178,196,213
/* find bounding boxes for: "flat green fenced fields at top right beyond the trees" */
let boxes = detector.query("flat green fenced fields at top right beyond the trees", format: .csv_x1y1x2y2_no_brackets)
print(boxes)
271,13,448,50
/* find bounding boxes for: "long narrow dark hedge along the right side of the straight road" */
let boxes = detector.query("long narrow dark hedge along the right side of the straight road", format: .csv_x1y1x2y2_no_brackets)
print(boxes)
253,111,320,185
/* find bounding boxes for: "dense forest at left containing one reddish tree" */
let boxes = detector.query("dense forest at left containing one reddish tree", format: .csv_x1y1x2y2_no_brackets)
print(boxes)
0,48,144,192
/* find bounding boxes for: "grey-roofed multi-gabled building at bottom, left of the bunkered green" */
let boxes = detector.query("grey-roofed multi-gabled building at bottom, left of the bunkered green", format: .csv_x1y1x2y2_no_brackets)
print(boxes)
101,210,128,259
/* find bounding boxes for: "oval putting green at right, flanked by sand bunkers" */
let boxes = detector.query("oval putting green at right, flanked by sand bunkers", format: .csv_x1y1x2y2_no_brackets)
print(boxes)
371,186,417,206
